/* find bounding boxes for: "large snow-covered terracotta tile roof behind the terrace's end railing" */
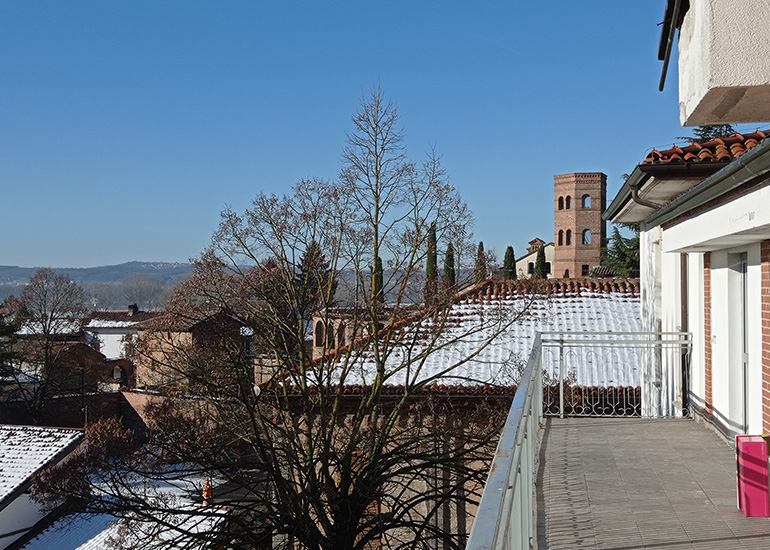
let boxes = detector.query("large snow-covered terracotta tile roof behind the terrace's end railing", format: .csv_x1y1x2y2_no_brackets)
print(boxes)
296,279,641,394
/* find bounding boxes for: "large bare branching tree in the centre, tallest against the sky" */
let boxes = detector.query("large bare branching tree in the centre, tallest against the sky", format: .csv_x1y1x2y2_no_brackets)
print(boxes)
34,89,521,550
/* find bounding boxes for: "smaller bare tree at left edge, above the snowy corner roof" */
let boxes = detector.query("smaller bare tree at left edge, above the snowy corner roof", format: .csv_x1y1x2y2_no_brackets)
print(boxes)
4,268,87,422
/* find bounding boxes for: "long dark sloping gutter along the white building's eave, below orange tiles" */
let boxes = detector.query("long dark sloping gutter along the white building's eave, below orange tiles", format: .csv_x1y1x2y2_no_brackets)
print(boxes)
644,139,770,227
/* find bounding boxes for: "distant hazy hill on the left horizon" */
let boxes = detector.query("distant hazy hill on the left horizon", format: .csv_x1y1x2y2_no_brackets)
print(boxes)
0,262,193,285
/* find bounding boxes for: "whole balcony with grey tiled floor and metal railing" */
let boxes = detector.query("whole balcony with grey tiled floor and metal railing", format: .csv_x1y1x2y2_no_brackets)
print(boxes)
467,333,770,550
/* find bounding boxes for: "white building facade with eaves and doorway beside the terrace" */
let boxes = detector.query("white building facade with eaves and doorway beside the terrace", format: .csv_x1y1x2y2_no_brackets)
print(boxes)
607,132,770,436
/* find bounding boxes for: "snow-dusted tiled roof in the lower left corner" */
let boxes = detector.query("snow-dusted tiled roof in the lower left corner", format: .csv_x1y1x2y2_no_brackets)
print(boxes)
0,425,83,509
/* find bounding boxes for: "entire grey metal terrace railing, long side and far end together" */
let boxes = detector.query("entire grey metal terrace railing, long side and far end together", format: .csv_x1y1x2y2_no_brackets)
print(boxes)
466,332,691,550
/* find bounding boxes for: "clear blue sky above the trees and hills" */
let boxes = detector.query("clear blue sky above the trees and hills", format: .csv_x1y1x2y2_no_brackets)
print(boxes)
0,0,756,267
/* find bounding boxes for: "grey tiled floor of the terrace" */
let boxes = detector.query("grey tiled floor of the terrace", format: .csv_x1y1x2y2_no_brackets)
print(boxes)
537,418,770,550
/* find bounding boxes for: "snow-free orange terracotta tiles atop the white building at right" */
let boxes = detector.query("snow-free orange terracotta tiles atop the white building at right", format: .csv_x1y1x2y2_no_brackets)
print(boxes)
642,129,770,165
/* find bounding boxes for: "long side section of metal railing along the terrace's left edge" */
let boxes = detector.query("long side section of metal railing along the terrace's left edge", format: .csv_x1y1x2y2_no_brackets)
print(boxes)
466,334,543,550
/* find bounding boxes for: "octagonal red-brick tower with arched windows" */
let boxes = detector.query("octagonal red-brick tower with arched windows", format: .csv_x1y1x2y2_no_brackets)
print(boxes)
553,172,607,278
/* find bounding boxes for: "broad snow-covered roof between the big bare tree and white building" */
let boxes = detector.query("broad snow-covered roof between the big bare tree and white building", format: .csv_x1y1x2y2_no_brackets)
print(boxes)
332,283,641,387
